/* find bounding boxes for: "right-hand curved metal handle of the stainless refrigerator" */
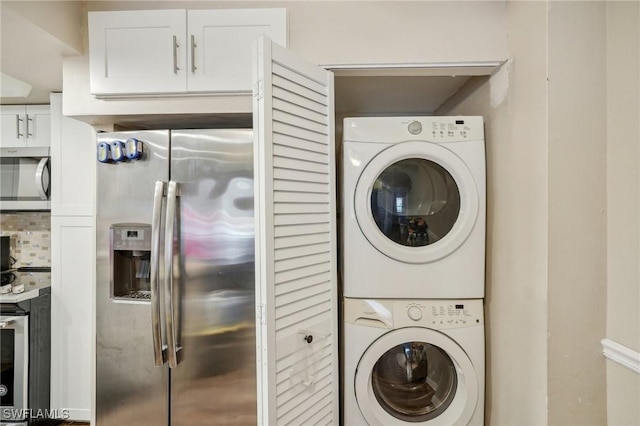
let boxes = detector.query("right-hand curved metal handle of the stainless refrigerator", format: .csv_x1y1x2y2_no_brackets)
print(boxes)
164,181,180,368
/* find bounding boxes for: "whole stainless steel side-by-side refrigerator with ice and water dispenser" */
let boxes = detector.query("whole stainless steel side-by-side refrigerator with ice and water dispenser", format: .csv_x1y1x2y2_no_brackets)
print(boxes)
96,129,257,426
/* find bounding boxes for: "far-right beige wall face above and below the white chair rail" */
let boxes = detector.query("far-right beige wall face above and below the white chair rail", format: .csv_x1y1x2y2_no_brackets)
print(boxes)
606,2,640,426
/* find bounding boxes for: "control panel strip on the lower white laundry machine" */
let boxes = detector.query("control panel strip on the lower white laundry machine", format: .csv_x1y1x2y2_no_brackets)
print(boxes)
344,298,484,330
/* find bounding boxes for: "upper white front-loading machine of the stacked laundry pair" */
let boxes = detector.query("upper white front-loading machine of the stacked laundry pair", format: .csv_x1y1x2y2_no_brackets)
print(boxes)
342,117,486,299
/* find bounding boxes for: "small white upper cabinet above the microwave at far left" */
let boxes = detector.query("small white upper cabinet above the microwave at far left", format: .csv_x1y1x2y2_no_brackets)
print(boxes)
0,105,51,148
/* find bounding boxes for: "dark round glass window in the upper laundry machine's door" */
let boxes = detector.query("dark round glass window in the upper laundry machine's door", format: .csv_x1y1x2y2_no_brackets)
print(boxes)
371,158,460,247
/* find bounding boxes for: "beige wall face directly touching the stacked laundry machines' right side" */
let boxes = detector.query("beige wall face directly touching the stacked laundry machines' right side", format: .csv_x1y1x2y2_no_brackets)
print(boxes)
438,2,548,425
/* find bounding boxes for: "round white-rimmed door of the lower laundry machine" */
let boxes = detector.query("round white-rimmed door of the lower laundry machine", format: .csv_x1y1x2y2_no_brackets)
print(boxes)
355,327,478,426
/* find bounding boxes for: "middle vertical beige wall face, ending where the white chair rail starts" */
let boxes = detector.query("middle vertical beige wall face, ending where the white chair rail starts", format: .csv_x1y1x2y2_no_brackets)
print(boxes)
547,1,607,425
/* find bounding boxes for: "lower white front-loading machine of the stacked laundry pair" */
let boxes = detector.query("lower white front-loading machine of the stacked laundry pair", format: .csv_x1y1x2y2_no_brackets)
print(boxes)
343,298,485,426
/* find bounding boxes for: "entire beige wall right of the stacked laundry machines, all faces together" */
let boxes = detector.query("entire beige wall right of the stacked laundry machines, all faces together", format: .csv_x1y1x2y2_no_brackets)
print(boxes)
439,1,640,425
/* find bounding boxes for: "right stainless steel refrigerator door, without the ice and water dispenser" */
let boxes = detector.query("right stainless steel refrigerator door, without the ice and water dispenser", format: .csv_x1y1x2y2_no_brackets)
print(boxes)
165,129,257,425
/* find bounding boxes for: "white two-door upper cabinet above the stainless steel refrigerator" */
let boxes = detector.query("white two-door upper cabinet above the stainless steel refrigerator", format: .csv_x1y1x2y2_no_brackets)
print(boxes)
89,9,287,96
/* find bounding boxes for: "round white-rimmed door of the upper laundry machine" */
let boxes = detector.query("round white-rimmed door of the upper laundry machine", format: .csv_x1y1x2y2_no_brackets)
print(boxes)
354,142,479,263
